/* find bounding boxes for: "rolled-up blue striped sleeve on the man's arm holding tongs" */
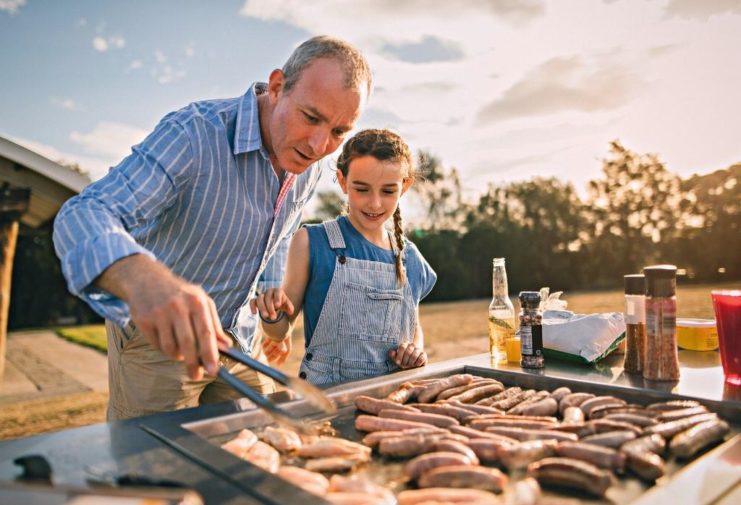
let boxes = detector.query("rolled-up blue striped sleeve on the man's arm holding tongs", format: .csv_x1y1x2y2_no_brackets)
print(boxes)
54,119,194,325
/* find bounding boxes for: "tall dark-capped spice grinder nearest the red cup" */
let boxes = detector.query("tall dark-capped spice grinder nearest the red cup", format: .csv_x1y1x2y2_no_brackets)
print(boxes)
642,265,679,381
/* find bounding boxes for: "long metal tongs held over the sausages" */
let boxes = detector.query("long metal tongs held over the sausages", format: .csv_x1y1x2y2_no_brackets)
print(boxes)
218,347,337,433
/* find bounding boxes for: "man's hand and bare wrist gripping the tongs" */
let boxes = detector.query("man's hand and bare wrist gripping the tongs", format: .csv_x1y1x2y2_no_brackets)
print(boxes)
96,255,231,380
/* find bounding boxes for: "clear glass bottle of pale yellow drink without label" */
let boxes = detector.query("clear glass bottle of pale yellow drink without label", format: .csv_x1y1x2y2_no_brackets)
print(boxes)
489,258,515,363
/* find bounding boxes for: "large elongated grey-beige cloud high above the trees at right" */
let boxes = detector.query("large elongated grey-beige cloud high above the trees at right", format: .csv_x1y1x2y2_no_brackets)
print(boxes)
476,56,635,125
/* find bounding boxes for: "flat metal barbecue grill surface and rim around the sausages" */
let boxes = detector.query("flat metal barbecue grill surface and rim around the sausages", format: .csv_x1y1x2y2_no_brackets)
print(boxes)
141,356,741,504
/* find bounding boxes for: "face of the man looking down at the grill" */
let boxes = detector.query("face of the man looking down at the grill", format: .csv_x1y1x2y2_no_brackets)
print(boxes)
263,58,367,174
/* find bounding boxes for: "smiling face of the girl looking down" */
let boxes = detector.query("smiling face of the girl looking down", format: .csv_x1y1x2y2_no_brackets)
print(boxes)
337,156,413,237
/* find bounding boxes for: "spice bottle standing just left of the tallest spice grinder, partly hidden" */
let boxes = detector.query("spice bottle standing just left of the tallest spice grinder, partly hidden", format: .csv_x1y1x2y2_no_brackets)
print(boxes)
623,274,646,373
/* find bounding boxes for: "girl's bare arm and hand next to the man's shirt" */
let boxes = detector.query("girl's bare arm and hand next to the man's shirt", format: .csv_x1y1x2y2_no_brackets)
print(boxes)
250,228,309,341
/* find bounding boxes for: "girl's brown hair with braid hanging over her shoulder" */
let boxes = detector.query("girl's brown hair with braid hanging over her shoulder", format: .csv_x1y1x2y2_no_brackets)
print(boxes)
337,129,414,284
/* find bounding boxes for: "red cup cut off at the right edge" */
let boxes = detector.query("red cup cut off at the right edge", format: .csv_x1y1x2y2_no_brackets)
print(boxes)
712,289,741,386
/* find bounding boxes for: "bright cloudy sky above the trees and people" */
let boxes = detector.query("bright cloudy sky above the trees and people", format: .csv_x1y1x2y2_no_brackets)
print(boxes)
0,0,741,204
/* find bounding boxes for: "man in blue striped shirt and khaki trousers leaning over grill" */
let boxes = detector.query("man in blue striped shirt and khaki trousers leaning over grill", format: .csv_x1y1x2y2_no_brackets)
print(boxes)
54,37,371,419
